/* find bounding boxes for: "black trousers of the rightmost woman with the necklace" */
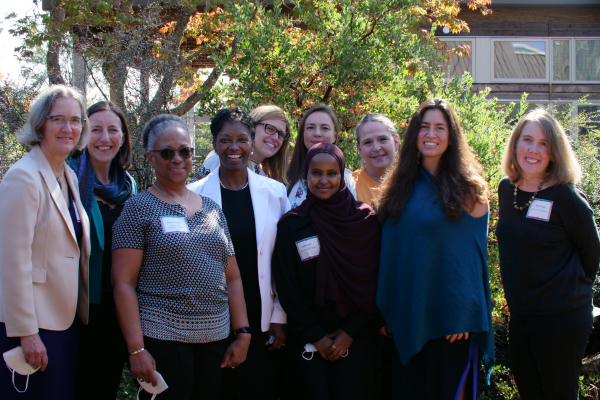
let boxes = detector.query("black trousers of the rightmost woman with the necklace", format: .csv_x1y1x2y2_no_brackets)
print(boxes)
508,302,594,400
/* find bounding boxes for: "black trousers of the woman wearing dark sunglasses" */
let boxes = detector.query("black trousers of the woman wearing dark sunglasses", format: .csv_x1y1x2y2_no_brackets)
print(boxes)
140,336,227,400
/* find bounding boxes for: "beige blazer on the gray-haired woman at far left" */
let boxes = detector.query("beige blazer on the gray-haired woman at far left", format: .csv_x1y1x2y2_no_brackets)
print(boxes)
0,145,90,337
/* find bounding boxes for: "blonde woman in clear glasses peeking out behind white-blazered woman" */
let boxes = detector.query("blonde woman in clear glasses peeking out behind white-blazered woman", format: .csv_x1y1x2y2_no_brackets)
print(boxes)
192,105,290,184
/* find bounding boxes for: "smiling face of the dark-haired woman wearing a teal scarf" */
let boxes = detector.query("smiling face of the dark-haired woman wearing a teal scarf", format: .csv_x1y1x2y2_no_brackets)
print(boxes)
87,111,125,164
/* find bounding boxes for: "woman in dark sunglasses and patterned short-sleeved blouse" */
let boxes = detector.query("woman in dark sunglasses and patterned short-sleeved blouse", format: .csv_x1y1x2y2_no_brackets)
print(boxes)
112,115,250,400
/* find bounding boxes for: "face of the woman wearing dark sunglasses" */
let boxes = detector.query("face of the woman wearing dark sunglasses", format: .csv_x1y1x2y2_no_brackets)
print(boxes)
146,126,192,187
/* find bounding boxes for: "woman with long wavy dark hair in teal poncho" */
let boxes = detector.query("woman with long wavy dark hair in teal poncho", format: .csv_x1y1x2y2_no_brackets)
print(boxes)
377,99,494,400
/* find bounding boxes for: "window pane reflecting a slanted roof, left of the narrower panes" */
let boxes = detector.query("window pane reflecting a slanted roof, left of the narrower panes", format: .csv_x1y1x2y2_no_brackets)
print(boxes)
493,40,546,81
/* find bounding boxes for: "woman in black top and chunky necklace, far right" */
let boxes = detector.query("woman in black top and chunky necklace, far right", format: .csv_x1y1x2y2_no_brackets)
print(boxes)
496,109,600,400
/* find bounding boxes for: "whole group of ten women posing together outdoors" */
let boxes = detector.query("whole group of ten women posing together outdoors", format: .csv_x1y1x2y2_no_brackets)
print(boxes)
0,85,600,400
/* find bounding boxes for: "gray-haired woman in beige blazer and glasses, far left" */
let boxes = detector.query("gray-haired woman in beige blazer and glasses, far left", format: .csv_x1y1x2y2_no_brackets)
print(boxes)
0,85,90,400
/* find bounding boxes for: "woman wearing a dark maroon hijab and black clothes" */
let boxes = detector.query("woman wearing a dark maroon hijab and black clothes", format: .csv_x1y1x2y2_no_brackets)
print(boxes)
272,143,381,400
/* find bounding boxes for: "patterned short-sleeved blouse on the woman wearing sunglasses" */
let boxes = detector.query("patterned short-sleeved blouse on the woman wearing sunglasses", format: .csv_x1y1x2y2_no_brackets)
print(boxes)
112,191,234,343
